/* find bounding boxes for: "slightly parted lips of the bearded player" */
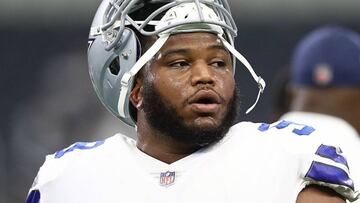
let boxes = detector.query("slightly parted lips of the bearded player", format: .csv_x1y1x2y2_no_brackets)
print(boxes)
189,90,221,114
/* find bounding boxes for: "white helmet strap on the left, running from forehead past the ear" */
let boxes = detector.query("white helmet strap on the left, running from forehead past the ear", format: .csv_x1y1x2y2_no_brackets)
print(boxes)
118,34,169,118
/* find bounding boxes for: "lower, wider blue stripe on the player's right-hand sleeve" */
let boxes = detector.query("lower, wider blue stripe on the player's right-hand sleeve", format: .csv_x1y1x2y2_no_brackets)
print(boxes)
305,161,354,190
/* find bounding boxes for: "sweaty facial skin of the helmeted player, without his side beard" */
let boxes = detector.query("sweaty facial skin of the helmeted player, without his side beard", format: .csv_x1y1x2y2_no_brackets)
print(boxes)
152,33,235,127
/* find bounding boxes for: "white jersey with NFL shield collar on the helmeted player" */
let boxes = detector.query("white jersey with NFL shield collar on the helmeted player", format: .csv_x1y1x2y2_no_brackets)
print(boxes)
27,121,358,203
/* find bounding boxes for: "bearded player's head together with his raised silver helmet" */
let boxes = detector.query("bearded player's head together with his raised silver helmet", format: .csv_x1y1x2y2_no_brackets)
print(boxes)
88,0,265,145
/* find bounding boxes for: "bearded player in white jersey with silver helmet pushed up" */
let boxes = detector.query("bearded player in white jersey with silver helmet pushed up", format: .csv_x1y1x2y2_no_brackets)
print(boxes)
27,0,358,203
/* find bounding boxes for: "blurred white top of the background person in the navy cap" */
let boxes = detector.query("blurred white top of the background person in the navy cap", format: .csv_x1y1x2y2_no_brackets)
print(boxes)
282,111,360,203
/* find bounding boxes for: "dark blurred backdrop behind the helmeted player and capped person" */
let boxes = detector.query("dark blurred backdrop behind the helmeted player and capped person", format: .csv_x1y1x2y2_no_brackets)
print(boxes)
0,0,360,203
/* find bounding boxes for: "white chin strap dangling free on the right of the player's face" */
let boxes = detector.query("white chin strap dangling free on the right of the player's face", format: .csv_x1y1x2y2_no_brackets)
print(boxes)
219,35,266,114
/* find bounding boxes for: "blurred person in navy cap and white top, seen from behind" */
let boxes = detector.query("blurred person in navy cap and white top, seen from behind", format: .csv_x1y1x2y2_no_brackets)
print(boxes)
282,26,360,203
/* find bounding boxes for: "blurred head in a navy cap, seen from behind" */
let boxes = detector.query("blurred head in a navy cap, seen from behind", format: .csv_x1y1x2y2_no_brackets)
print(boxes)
291,26,360,131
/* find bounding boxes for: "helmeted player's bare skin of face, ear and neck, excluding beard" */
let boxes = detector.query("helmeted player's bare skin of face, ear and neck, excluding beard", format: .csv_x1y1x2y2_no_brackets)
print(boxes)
130,33,235,163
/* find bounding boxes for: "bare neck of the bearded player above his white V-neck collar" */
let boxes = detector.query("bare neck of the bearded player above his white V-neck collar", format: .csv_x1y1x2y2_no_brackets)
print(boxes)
136,114,200,164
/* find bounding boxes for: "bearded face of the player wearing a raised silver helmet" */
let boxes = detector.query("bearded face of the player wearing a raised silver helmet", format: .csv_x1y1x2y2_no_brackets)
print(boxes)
143,33,238,145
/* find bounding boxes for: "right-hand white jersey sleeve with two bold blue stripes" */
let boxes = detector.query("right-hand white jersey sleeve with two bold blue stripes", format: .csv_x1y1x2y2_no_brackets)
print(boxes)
302,144,360,202
